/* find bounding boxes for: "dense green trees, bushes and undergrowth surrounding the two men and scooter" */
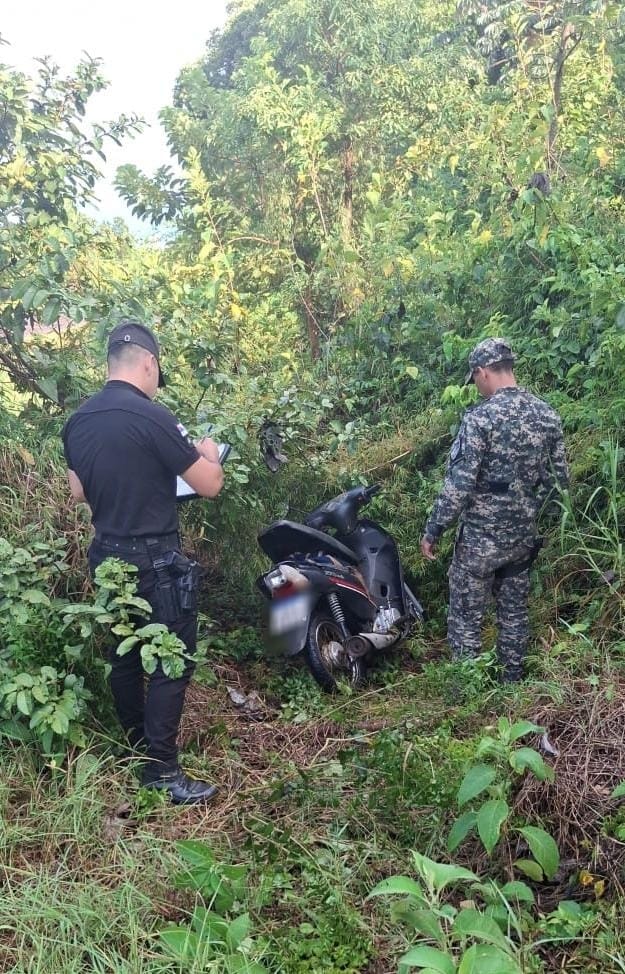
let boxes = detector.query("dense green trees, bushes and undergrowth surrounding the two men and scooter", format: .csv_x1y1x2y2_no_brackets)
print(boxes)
0,0,625,974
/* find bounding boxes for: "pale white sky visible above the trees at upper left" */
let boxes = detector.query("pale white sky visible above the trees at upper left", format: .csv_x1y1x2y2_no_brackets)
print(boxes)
0,0,226,232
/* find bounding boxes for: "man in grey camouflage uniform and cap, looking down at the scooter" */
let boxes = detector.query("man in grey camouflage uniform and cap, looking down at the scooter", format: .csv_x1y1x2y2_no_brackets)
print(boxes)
421,338,568,681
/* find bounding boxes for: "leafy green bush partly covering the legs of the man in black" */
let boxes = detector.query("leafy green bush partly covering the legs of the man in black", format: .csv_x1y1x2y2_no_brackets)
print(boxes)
0,538,191,761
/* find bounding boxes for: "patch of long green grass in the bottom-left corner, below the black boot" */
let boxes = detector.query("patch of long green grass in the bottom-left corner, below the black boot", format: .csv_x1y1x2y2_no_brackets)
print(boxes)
0,748,185,974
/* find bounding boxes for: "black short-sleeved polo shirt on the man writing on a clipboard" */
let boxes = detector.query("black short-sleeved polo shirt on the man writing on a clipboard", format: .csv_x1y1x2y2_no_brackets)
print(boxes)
62,379,200,538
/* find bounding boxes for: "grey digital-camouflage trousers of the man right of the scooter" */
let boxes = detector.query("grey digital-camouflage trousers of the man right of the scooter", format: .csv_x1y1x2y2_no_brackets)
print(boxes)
447,532,533,680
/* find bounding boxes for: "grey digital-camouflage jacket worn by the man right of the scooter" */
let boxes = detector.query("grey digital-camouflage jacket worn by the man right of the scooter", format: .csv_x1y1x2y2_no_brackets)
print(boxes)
425,386,568,545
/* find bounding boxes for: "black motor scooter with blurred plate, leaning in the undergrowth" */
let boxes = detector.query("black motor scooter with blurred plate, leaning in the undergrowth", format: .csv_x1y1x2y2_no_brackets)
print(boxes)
256,484,423,691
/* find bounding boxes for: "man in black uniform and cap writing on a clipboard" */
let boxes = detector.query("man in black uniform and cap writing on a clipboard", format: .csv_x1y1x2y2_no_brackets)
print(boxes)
63,320,223,804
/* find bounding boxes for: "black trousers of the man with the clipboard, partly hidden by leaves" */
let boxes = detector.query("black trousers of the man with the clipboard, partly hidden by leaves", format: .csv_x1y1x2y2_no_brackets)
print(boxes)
89,534,197,781
